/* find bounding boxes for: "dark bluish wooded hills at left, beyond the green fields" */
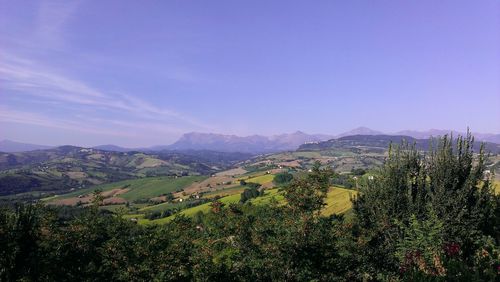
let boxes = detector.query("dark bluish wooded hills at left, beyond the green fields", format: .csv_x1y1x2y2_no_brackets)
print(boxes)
0,146,251,195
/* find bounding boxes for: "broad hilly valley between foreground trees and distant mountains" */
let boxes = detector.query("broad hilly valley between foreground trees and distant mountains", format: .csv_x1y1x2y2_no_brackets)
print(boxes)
0,132,500,224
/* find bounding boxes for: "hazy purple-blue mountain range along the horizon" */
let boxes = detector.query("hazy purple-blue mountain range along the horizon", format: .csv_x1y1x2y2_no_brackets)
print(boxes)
0,127,500,154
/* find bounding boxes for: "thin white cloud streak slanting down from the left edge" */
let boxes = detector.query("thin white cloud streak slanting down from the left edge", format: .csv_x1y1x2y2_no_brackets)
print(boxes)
0,54,210,130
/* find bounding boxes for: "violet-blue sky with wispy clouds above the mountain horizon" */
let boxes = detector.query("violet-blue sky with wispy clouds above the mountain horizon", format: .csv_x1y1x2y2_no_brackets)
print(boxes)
0,0,500,146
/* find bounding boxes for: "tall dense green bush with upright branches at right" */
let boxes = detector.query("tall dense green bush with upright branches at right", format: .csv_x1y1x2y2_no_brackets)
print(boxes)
354,134,499,277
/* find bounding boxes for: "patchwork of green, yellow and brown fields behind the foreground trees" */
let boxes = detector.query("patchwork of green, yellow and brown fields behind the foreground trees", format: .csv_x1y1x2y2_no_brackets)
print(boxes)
40,152,500,227
